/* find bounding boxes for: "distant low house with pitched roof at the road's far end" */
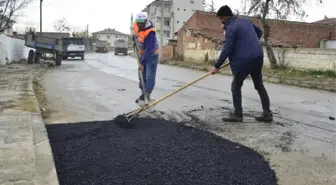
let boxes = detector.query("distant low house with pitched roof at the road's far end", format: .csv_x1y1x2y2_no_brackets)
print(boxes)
92,28,129,48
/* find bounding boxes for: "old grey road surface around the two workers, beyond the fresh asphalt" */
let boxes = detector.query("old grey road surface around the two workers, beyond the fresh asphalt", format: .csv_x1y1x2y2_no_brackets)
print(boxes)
44,53,336,185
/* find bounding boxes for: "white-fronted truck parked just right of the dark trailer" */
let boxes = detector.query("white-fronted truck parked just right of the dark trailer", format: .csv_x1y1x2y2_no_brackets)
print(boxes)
62,37,85,60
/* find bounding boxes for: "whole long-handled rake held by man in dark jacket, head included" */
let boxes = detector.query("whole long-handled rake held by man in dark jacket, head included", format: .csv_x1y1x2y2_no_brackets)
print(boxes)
114,63,229,128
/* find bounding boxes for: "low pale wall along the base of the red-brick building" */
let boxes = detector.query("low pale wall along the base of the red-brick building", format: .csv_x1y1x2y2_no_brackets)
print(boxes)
183,48,336,70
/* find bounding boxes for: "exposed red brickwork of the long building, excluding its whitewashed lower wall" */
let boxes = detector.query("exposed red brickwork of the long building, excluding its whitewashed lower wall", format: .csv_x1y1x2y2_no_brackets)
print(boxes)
177,11,336,53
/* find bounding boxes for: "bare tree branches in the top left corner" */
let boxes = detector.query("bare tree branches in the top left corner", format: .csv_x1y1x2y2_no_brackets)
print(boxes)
0,0,32,33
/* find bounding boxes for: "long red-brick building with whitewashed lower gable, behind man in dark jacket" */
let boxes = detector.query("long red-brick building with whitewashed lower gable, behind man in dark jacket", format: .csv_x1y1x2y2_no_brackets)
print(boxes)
164,11,336,62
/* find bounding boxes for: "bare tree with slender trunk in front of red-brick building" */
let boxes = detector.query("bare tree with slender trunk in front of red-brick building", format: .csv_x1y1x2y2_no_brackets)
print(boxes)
248,0,322,69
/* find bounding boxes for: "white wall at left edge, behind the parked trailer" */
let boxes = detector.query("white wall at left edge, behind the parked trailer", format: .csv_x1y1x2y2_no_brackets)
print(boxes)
0,35,30,65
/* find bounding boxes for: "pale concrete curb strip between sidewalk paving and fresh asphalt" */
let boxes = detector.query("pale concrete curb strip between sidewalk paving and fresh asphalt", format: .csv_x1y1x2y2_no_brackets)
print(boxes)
28,76,59,185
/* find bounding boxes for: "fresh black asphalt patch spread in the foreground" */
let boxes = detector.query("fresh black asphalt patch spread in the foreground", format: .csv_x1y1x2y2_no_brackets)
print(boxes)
47,118,277,185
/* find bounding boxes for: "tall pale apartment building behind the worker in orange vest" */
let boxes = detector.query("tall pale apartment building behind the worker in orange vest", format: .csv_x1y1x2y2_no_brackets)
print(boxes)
143,0,204,44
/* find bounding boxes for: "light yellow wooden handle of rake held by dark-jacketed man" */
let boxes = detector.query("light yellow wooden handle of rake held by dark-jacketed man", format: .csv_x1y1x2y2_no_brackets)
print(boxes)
128,63,229,115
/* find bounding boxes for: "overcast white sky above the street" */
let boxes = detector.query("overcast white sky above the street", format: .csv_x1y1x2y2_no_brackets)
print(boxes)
14,0,336,33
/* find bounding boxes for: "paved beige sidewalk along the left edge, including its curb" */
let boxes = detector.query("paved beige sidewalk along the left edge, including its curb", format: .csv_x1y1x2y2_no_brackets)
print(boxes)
0,64,59,185
